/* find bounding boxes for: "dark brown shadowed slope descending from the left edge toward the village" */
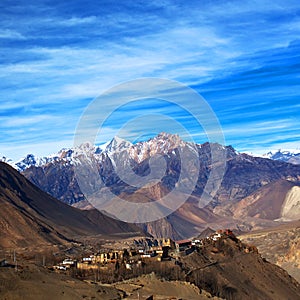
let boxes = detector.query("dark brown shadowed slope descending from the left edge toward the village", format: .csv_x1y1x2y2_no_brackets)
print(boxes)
0,162,141,248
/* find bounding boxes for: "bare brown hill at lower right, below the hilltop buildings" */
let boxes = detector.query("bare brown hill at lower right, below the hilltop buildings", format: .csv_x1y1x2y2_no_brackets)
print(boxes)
182,237,300,300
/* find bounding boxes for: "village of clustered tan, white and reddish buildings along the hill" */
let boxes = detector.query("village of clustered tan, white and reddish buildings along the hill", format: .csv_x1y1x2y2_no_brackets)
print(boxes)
54,229,235,271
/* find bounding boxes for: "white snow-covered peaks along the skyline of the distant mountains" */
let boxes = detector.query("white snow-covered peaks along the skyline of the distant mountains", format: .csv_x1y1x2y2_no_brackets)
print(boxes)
0,133,300,172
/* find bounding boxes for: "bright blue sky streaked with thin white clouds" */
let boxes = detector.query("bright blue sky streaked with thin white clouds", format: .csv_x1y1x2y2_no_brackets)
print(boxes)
0,0,300,159
